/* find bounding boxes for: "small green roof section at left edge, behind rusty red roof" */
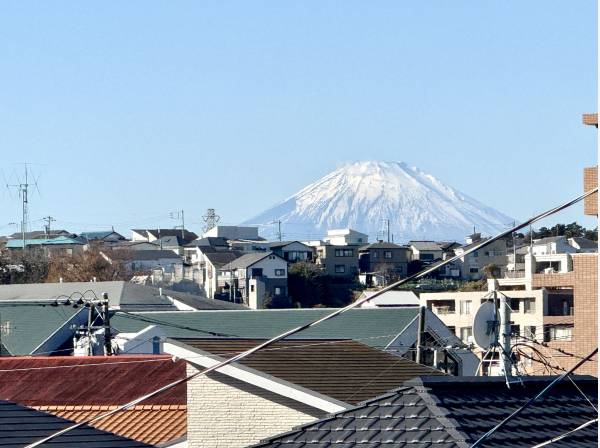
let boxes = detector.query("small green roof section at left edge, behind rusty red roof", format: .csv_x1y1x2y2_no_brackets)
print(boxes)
0,302,87,356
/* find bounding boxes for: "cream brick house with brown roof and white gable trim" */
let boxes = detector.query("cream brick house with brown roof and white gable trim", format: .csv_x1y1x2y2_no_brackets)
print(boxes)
164,338,443,448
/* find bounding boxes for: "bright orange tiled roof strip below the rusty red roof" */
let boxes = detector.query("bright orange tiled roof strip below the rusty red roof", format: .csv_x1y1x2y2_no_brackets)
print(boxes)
36,404,187,445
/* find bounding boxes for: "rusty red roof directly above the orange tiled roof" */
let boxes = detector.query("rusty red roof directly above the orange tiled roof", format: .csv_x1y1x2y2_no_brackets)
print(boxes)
0,355,186,406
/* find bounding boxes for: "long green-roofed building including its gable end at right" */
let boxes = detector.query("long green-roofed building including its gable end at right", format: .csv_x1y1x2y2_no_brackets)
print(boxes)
111,306,478,375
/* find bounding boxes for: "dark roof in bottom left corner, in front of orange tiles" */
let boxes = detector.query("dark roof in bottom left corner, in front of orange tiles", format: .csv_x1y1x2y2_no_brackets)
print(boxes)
0,400,151,448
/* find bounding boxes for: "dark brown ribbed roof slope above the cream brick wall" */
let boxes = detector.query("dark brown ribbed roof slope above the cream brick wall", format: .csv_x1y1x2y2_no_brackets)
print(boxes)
179,339,442,404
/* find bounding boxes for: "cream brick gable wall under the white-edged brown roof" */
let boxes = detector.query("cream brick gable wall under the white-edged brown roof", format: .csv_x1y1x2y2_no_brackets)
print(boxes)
187,364,325,448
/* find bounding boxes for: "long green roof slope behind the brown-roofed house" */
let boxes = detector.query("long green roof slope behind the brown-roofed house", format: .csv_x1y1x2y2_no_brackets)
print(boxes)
111,307,419,348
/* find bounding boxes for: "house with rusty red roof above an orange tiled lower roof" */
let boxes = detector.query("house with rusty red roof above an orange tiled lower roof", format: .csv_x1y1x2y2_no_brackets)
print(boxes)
0,355,187,448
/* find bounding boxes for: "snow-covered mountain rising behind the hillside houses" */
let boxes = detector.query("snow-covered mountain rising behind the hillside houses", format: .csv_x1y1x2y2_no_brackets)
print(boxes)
245,161,513,242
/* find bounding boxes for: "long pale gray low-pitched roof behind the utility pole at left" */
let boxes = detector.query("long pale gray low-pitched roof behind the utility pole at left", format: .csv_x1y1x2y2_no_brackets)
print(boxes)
0,281,175,310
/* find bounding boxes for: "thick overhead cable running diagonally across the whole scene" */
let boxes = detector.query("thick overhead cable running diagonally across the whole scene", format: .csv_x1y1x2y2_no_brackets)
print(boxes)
21,188,598,448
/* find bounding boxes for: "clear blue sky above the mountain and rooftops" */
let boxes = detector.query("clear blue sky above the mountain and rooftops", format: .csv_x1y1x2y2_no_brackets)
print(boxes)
0,0,597,234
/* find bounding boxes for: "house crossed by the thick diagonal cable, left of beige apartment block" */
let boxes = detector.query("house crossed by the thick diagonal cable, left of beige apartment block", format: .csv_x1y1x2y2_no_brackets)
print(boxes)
454,233,508,280
